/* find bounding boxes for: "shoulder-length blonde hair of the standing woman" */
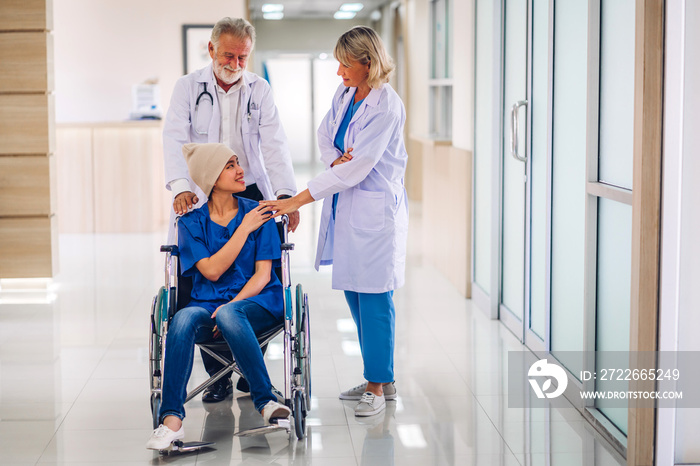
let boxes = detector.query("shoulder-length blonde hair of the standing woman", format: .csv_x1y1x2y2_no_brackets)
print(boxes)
333,26,395,89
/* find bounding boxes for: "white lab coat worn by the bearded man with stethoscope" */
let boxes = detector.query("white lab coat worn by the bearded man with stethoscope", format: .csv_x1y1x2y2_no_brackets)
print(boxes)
163,64,296,209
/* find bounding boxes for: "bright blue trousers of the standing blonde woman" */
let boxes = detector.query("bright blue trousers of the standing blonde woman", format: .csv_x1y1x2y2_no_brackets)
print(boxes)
345,291,396,383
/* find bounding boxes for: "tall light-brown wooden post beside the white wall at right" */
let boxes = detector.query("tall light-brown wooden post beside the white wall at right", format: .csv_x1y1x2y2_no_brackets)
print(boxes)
627,0,664,466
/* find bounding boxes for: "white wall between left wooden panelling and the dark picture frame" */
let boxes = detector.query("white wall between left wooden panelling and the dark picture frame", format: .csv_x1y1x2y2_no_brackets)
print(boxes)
53,0,246,123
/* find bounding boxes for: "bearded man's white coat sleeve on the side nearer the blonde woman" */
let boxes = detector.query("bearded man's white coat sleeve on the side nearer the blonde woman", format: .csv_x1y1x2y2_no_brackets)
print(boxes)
259,83,297,196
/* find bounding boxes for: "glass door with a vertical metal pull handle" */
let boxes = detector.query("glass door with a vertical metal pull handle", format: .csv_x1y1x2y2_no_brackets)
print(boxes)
499,0,551,350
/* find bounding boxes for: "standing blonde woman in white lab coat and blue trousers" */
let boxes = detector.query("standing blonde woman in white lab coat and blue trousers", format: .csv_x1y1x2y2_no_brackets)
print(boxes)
261,26,408,416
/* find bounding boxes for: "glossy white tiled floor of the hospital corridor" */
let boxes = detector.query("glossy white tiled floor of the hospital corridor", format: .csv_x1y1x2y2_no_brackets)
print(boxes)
0,201,624,466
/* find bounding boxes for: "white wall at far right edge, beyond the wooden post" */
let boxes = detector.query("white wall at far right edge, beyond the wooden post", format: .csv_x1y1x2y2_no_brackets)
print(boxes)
656,0,700,465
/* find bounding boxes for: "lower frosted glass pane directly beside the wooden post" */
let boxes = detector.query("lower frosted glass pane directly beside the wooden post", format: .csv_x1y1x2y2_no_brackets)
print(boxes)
596,198,632,433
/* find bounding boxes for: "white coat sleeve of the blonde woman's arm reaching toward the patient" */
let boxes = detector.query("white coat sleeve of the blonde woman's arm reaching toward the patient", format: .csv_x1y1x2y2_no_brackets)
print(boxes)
308,111,401,200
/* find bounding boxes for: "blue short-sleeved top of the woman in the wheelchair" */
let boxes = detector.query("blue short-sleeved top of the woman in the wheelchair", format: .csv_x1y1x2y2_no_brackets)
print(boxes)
178,196,284,317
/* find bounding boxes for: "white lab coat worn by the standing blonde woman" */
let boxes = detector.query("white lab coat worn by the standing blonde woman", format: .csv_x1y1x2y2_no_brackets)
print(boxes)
308,84,408,293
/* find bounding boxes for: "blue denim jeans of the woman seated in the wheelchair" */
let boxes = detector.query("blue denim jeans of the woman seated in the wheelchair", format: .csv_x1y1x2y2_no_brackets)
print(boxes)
160,300,283,421
